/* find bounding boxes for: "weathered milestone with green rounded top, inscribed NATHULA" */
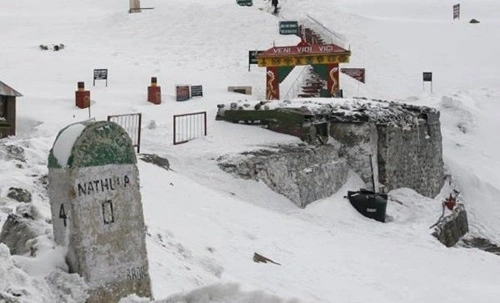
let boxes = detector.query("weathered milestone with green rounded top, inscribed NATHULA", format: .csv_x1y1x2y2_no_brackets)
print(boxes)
49,121,152,303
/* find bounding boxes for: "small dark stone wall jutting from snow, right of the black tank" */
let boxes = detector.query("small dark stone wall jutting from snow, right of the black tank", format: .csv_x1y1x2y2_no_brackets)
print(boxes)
433,204,469,247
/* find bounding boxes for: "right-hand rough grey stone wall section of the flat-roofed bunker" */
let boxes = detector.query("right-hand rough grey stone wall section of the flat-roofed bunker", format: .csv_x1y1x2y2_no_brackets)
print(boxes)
377,113,444,197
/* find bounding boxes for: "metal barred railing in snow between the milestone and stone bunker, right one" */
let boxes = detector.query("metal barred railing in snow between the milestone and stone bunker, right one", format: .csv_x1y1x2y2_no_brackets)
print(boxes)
174,112,207,145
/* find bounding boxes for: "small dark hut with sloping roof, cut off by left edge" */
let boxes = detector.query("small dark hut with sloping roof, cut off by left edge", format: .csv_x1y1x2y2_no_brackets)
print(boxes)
0,81,22,139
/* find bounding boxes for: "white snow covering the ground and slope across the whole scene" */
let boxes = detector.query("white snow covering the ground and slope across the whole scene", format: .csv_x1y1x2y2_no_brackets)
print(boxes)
0,0,500,303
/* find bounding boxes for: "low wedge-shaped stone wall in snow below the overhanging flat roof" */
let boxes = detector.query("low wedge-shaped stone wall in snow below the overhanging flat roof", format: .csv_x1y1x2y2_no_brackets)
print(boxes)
219,145,349,208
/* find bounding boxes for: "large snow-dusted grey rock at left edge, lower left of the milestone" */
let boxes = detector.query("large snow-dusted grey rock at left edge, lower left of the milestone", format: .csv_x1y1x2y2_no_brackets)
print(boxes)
0,214,39,255
